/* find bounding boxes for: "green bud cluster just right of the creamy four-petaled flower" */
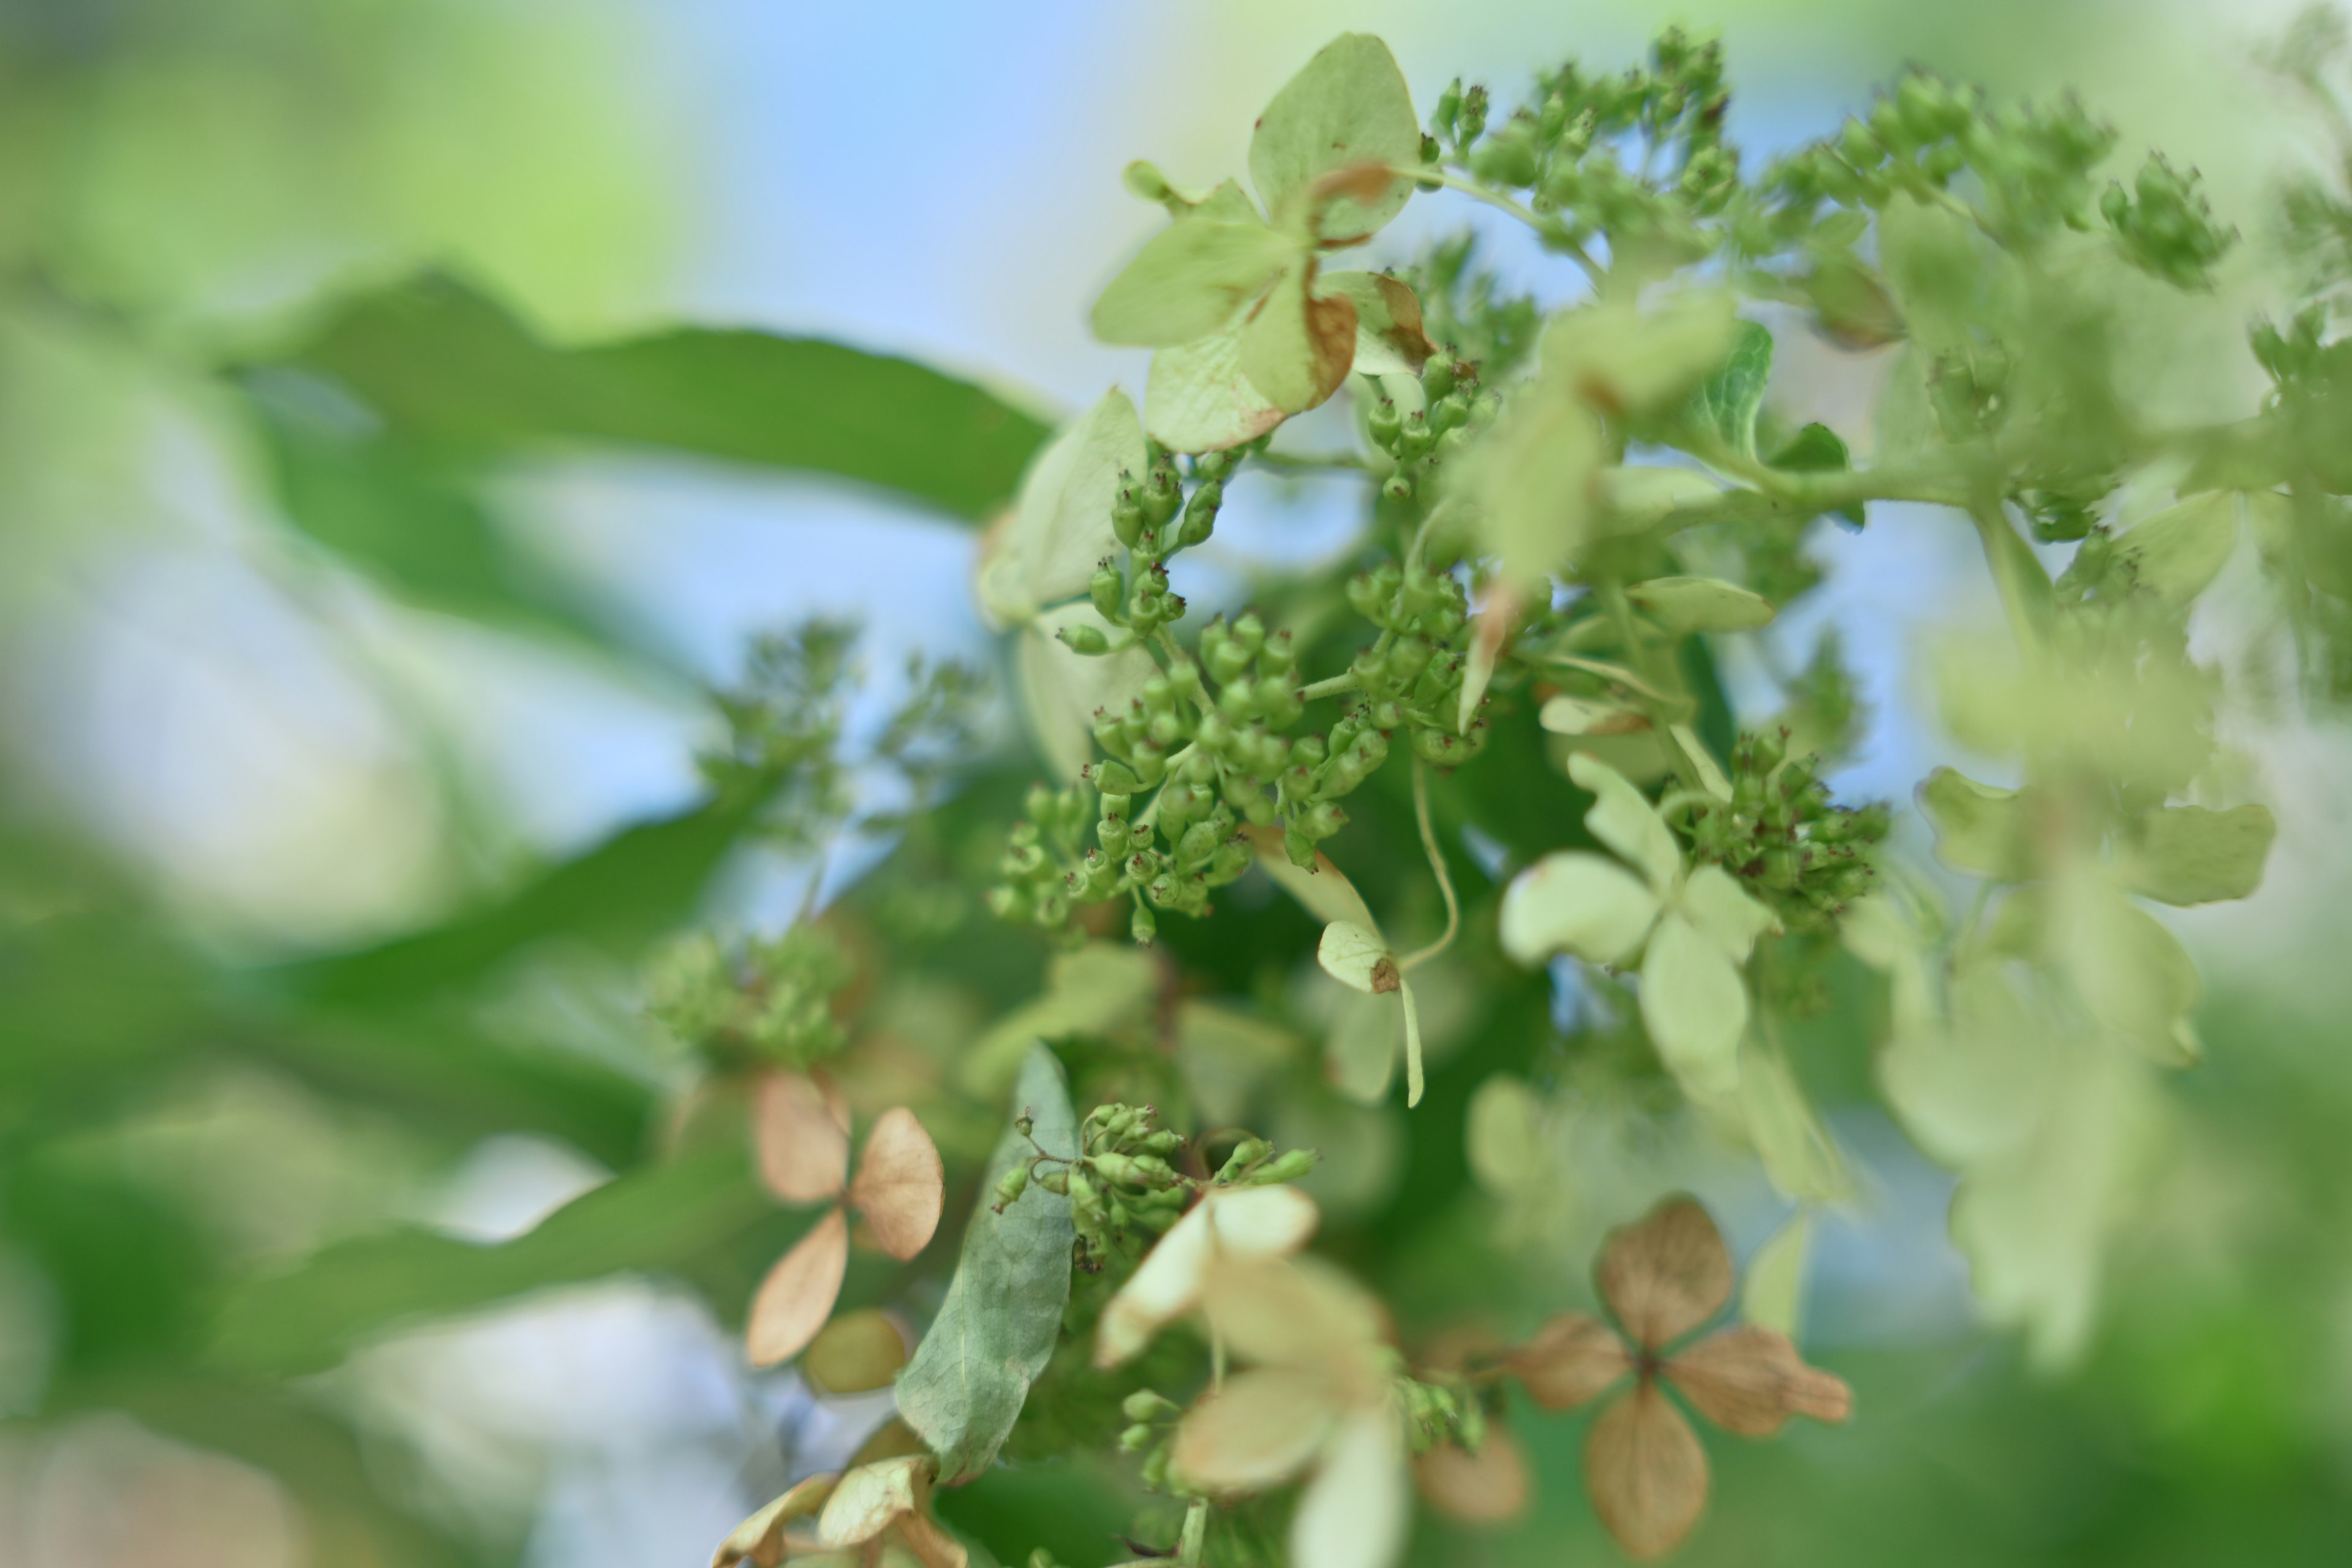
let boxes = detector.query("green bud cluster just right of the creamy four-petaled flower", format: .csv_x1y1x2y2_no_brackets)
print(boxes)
1689,729,1891,933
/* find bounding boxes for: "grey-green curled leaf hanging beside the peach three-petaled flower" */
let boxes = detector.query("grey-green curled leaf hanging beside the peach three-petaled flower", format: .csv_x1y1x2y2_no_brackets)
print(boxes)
899,1046,1077,1486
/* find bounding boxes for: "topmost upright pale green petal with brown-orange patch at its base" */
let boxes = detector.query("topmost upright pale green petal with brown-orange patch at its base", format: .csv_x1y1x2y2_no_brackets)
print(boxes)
1249,33,1420,244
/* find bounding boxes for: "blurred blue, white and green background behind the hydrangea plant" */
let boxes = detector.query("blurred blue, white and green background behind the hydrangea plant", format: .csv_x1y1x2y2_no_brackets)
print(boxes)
0,0,2352,1568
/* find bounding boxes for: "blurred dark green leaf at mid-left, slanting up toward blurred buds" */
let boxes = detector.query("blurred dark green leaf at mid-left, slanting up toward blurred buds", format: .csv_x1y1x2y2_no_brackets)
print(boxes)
273,794,764,1006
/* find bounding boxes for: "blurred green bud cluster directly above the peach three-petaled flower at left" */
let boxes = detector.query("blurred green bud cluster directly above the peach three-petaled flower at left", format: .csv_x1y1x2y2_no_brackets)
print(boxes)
644,926,851,1067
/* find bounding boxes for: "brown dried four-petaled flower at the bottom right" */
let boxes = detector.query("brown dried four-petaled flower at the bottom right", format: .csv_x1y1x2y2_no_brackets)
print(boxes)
1506,1197,1853,1556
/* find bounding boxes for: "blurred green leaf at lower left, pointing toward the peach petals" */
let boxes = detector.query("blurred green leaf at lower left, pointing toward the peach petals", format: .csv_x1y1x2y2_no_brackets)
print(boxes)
212,1145,778,1375
